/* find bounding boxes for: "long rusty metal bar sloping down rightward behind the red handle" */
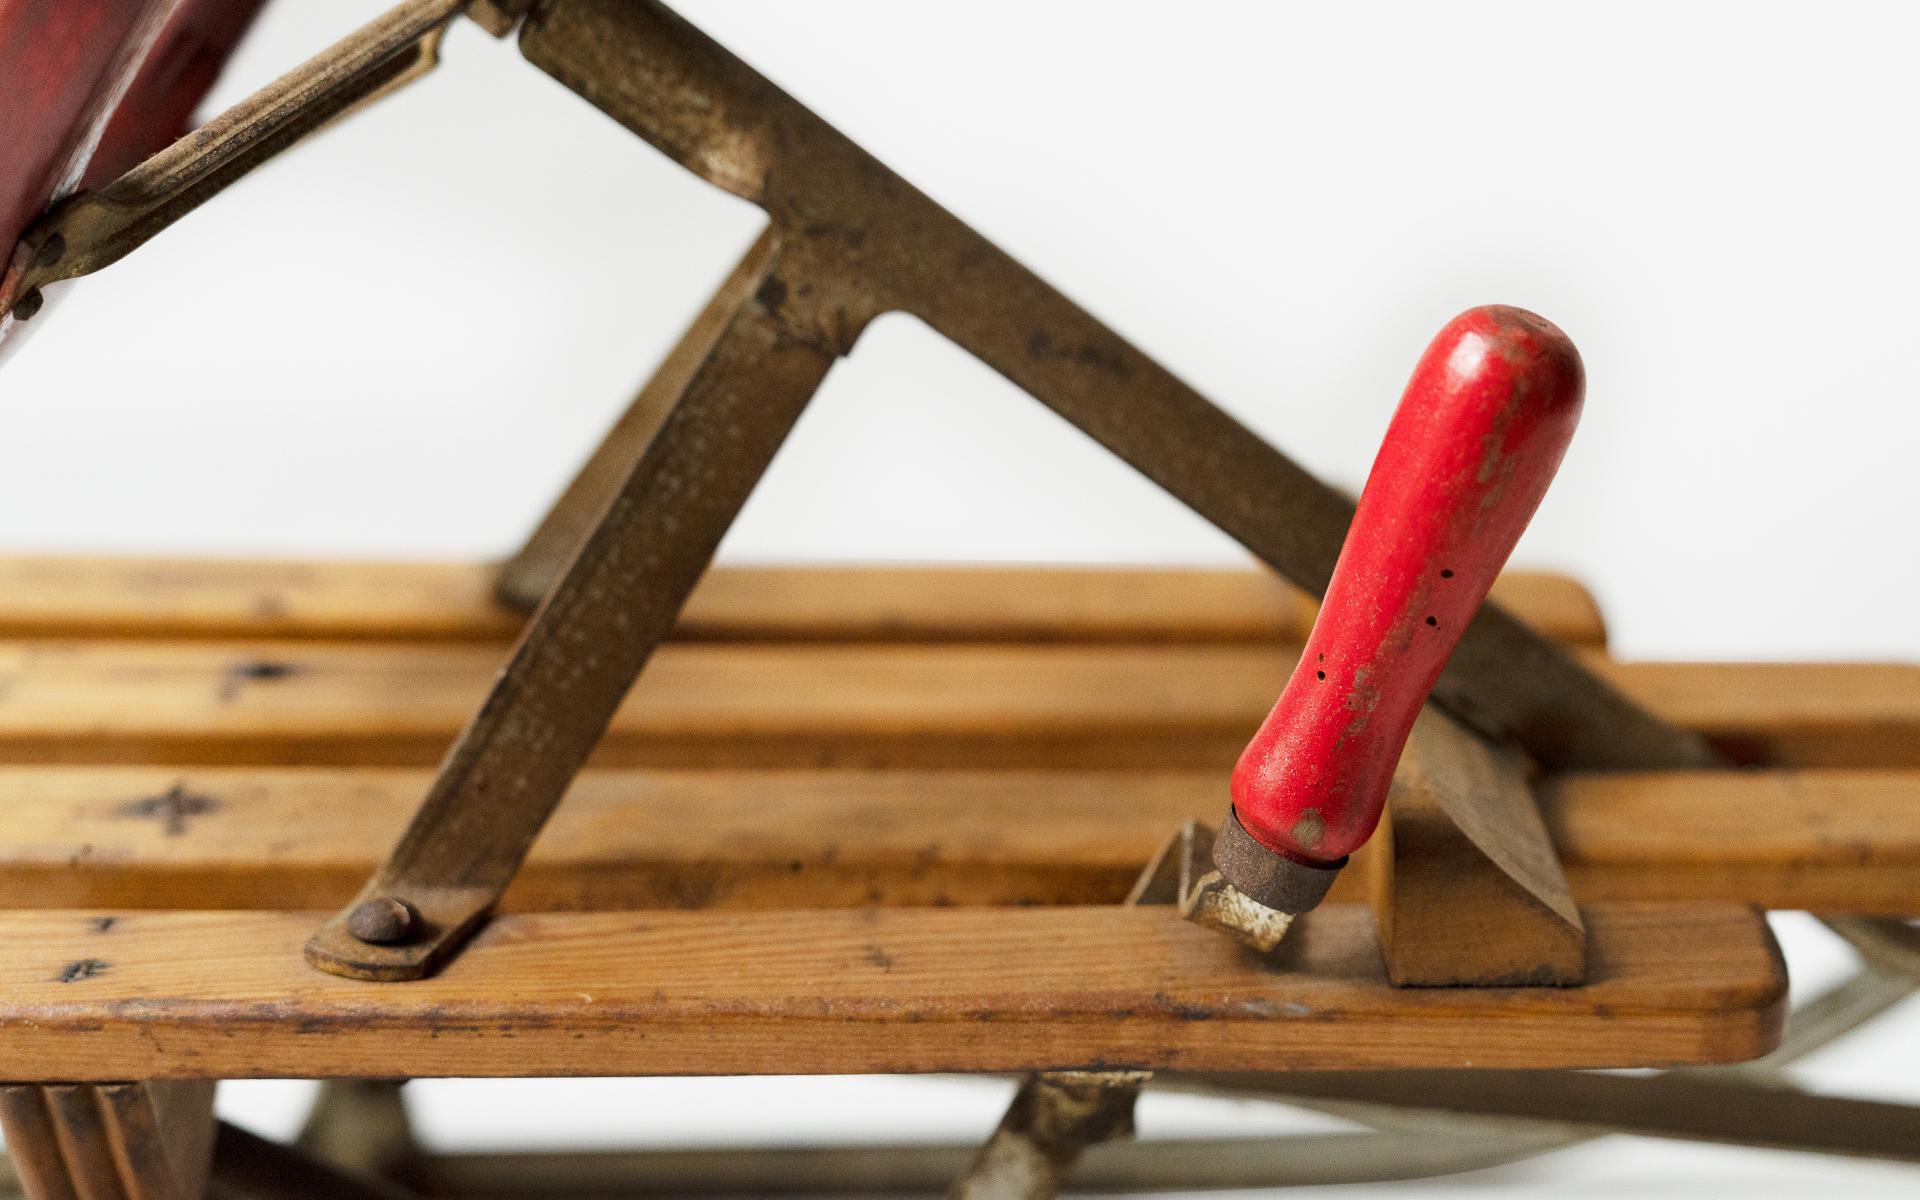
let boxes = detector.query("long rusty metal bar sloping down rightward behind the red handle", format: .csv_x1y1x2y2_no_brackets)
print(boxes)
520,0,1718,768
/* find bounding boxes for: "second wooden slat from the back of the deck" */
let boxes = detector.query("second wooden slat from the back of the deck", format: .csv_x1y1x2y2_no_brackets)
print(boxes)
0,641,1920,766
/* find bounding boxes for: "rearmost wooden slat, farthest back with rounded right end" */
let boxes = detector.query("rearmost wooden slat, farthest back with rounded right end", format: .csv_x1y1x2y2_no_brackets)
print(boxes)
0,557,1607,645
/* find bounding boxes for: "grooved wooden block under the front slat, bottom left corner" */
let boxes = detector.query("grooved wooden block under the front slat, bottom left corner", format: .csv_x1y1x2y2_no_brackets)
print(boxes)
0,1075,213,1200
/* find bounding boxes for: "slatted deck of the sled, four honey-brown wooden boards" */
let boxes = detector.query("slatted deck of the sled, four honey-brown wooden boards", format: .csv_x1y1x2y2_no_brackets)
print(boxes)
0,561,1920,1081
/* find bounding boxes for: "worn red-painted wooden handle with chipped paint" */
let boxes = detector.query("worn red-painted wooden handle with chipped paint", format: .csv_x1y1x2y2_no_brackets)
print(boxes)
1233,305,1586,866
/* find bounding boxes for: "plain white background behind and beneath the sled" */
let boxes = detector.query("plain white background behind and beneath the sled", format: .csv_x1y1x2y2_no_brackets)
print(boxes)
0,0,1920,1196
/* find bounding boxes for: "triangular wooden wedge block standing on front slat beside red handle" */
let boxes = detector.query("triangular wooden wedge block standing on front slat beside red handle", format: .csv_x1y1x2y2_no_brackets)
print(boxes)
1369,708,1586,987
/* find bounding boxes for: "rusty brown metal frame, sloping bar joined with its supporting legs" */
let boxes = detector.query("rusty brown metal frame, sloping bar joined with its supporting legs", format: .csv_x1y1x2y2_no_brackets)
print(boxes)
307,0,1718,979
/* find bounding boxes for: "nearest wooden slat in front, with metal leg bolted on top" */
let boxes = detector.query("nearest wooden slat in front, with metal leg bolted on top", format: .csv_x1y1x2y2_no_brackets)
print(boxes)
0,904,1786,1081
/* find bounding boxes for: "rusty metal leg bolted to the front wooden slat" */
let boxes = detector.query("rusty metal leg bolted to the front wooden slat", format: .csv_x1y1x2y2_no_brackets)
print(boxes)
307,239,841,979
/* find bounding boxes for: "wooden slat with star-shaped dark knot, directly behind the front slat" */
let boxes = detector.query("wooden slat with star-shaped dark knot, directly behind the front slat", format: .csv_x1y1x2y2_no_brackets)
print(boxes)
0,766,1920,916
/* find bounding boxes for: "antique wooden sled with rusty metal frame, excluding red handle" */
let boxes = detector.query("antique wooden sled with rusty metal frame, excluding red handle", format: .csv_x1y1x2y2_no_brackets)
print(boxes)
0,0,1920,1200
